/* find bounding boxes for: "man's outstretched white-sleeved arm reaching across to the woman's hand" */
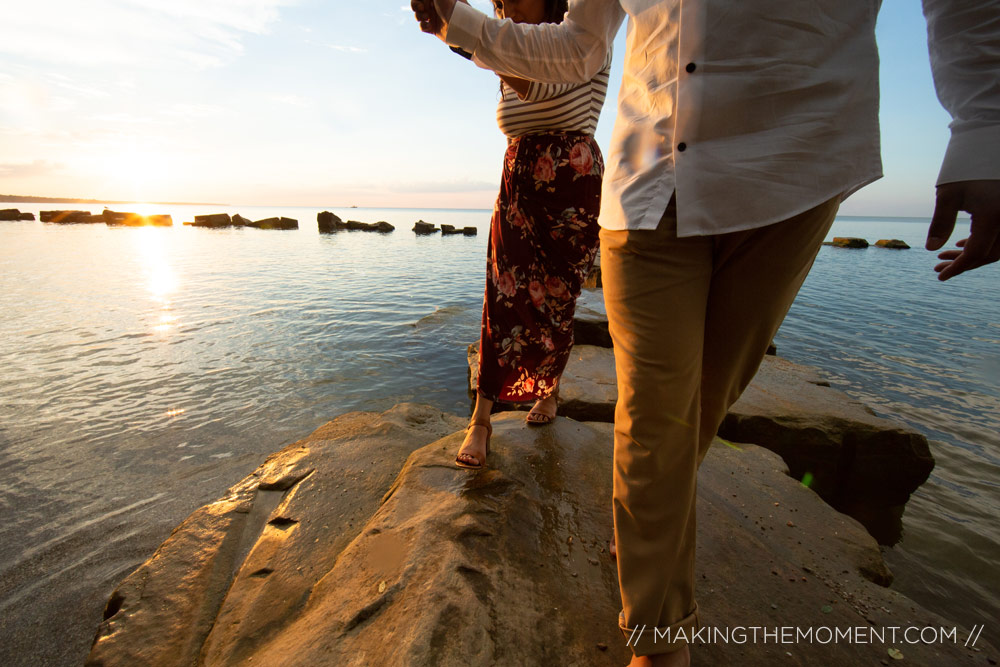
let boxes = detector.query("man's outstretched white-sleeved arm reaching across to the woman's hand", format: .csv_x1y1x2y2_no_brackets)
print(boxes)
410,0,625,83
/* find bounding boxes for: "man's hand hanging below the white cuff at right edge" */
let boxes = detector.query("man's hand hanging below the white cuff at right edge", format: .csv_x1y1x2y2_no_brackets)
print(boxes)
926,180,1000,280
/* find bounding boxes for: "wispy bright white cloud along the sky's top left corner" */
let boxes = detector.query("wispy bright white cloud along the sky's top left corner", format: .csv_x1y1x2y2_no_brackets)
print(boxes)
0,0,295,68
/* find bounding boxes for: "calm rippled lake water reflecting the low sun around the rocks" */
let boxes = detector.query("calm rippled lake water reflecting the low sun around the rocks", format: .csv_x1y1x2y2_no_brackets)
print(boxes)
0,203,1000,665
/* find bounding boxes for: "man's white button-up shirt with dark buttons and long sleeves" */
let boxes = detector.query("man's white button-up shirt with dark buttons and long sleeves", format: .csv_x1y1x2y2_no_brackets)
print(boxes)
445,0,1000,236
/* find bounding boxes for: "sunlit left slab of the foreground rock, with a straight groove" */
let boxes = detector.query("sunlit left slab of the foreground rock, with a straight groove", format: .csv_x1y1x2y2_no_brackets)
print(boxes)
88,404,465,665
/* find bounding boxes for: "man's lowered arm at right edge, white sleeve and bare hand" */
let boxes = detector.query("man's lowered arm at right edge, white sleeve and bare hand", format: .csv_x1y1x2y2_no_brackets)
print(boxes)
923,0,1000,280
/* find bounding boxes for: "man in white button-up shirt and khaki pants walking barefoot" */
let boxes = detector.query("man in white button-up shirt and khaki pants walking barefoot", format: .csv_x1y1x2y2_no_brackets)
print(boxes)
411,0,1000,666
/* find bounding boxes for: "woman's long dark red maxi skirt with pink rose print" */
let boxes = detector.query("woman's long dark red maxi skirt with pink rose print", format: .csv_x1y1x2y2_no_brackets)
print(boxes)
478,133,604,402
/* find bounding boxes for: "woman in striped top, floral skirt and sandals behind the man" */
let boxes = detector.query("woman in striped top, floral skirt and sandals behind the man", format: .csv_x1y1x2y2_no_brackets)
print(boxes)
455,0,611,468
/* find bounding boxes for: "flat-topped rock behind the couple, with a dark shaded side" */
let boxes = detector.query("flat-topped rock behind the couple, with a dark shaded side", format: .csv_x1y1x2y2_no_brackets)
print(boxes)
468,343,934,510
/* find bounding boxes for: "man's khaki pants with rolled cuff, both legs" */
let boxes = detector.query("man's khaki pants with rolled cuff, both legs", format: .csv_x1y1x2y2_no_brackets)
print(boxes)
601,196,840,655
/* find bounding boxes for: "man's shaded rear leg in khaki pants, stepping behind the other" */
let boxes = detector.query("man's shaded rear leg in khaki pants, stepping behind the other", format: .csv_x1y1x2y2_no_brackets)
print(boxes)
698,196,840,464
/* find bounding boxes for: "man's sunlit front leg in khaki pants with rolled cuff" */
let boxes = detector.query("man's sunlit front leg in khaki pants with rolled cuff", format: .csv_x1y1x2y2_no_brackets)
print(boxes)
601,202,713,656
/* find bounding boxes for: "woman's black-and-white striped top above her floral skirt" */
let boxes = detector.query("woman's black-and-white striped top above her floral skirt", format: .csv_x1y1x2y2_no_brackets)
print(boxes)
497,49,611,138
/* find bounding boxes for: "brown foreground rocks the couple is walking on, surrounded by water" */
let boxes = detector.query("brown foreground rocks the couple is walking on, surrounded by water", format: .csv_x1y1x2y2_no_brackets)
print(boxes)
87,292,997,665
